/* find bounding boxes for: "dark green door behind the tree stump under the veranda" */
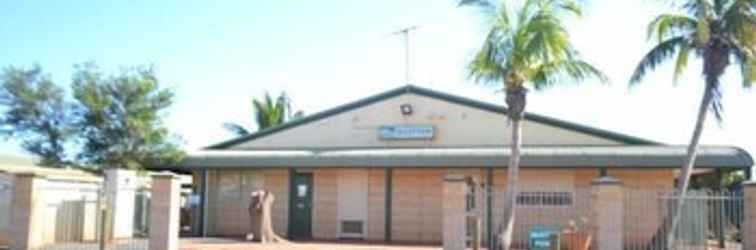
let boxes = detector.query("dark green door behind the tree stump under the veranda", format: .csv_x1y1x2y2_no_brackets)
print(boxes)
289,172,312,239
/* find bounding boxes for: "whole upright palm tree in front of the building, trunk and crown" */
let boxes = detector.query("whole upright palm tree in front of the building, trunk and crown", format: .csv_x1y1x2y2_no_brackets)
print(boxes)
459,0,608,249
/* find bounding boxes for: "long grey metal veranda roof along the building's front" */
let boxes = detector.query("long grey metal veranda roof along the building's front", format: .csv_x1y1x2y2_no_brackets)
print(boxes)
181,145,753,168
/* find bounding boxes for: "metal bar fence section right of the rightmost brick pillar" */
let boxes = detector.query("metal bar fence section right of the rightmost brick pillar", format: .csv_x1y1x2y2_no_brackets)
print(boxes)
623,189,744,250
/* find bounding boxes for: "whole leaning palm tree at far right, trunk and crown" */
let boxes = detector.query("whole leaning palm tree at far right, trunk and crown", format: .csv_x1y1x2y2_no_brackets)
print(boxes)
630,0,756,247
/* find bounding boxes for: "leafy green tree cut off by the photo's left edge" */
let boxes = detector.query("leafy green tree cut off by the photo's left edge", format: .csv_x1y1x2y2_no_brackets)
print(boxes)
0,65,73,167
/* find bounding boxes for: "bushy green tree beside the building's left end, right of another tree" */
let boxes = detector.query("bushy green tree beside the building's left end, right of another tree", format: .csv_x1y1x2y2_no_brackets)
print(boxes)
72,64,183,169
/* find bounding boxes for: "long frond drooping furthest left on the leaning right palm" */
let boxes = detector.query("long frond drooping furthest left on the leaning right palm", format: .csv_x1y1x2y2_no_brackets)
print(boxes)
630,36,687,86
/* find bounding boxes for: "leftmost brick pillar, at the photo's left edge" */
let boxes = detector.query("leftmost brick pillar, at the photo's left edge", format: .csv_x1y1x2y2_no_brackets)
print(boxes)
9,173,42,250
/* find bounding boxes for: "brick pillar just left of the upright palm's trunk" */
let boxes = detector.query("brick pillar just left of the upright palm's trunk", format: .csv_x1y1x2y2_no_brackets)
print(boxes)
443,175,467,250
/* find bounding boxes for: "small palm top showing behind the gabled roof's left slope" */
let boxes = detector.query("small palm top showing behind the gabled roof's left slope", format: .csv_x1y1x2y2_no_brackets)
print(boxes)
223,92,304,136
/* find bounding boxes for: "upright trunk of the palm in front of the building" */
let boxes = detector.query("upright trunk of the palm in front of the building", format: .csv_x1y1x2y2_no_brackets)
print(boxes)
498,84,527,250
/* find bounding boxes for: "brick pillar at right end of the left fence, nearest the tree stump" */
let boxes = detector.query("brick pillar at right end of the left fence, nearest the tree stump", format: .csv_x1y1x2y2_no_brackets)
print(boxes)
150,174,181,250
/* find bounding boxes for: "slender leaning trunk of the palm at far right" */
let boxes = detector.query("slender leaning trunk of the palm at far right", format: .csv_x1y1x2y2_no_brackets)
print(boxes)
646,85,714,249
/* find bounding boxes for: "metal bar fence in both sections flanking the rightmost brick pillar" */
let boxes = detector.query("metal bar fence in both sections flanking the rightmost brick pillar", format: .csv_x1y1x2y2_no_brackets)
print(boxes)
484,187,744,250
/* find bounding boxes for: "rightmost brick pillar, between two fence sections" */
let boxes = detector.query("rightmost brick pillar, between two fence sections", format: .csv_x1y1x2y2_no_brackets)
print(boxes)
591,176,624,250
